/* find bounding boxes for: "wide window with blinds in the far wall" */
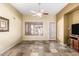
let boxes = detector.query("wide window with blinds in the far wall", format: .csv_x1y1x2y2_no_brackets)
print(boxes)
25,22,43,35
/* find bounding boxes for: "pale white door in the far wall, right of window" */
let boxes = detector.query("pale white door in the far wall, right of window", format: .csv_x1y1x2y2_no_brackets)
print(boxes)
49,22,56,40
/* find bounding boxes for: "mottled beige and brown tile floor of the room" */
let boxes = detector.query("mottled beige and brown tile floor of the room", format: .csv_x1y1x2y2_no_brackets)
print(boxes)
1,41,79,56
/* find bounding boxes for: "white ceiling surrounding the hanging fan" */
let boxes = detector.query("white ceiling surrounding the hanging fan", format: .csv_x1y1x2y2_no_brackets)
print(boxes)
11,3,68,15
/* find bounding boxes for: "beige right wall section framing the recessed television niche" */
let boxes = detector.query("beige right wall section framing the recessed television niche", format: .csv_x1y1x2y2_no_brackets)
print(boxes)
56,3,79,44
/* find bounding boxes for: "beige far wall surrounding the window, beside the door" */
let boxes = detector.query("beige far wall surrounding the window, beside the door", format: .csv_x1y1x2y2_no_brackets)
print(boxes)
23,15,56,40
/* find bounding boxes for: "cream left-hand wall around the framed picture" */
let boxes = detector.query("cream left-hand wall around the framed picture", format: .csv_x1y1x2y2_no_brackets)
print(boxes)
0,4,22,53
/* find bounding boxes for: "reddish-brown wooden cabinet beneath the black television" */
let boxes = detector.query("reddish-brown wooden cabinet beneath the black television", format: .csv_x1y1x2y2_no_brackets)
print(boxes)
70,36,79,52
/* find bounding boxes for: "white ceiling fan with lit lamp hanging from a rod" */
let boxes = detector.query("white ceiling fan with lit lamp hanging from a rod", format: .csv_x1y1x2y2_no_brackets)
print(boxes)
30,3,48,17
